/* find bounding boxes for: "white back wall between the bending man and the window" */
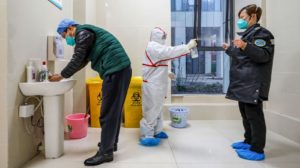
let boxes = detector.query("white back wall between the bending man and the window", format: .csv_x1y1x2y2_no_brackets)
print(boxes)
87,0,171,76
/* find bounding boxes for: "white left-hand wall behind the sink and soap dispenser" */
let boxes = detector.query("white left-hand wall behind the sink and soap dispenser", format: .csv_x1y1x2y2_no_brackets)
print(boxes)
5,0,73,168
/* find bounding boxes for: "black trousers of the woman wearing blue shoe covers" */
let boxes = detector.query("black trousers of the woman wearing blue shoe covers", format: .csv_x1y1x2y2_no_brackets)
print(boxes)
239,101,266,153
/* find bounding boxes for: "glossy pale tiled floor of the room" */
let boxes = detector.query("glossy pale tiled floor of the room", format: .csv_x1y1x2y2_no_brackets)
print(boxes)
25,120,300,168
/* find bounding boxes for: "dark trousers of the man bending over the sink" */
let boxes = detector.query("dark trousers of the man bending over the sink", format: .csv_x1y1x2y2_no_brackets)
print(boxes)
100,66,132,154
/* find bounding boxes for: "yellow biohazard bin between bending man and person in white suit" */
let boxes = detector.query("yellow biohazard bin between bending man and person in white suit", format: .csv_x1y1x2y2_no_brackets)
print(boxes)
124,76,143,128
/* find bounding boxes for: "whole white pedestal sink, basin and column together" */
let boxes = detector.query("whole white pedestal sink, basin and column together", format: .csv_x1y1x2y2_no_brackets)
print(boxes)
19,79,76,159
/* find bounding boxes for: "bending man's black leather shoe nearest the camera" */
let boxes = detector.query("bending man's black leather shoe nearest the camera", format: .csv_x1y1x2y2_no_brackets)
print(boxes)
84,151,114,166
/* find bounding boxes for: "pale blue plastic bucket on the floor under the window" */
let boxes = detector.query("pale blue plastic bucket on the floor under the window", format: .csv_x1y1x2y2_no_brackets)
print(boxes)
169,107,189,128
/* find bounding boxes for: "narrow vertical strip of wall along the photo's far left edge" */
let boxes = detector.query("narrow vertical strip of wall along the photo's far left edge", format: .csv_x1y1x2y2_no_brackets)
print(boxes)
0,0,8,168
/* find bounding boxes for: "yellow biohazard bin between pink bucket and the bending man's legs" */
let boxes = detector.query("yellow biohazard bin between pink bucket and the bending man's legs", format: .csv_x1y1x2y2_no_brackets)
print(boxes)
86,77,102,128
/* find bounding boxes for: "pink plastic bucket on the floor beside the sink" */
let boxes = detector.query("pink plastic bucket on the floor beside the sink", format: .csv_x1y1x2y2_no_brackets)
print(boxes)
65,113,90,139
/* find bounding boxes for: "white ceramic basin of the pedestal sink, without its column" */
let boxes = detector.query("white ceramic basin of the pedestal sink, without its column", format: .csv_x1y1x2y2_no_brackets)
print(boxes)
19,79,76,96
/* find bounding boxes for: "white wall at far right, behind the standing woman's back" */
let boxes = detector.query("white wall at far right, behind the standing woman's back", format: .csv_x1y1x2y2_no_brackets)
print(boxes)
266,0,300,143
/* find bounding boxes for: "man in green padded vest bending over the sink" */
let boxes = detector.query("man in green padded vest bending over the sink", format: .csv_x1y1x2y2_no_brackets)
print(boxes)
50,19,132,166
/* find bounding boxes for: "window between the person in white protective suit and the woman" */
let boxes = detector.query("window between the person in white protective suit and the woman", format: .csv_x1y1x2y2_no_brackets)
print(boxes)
171,0,233,94
